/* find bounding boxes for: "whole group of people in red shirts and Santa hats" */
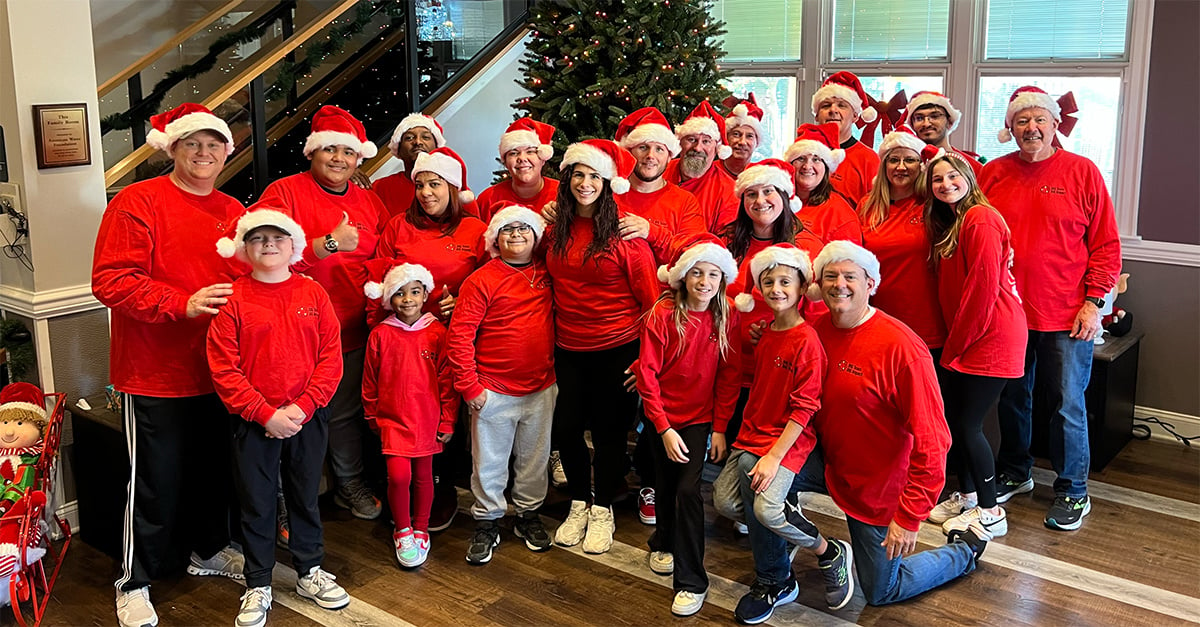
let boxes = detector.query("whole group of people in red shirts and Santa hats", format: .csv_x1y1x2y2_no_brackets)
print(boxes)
94,66,1120,627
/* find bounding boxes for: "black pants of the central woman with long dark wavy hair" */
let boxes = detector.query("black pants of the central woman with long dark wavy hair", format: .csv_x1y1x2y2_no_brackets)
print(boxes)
553,340,638,507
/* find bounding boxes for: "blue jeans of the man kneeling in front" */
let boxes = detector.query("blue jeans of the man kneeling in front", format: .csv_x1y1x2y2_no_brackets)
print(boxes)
846,515,976,605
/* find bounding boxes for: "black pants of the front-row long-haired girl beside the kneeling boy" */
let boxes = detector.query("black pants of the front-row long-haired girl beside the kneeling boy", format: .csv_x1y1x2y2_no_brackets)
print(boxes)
648,423,712,592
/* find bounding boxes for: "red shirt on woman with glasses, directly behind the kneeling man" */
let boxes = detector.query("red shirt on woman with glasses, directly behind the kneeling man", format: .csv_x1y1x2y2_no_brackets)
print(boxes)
863,197,946,348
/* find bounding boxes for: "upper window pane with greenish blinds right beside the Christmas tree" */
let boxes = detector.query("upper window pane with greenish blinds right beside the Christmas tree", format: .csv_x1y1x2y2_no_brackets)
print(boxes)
709,0,804,62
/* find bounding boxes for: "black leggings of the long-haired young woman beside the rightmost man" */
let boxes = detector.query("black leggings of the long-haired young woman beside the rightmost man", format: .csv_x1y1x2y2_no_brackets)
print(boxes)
941,369,1009,508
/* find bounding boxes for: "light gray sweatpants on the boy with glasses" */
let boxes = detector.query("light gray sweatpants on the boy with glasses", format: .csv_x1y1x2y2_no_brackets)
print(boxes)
470,383,558,520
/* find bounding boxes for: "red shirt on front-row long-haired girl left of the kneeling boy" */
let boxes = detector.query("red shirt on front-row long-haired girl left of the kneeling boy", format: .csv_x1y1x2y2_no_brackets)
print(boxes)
634,297,740,434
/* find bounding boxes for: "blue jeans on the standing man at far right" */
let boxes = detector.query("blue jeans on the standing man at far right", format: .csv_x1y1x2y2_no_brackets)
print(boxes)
996,330,1093,498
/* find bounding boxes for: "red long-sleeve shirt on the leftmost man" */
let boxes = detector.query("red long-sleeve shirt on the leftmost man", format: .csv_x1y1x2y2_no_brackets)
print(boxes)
91,177,246,398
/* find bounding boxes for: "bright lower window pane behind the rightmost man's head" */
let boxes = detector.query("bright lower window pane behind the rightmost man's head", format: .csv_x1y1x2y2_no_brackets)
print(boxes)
976,76,1121,193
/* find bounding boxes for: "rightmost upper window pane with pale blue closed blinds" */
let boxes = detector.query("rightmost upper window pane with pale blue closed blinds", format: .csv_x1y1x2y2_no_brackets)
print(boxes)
985,0,1130,59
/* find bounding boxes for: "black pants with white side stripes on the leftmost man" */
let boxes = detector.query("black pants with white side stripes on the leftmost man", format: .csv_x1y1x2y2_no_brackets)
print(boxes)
118,394,233,591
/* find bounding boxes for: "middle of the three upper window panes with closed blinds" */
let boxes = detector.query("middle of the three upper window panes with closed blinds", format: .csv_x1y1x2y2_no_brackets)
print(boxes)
833,0,950,61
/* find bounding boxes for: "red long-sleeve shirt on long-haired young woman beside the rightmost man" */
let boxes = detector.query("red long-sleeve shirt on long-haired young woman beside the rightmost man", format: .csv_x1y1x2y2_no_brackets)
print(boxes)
937,205,1028,378
